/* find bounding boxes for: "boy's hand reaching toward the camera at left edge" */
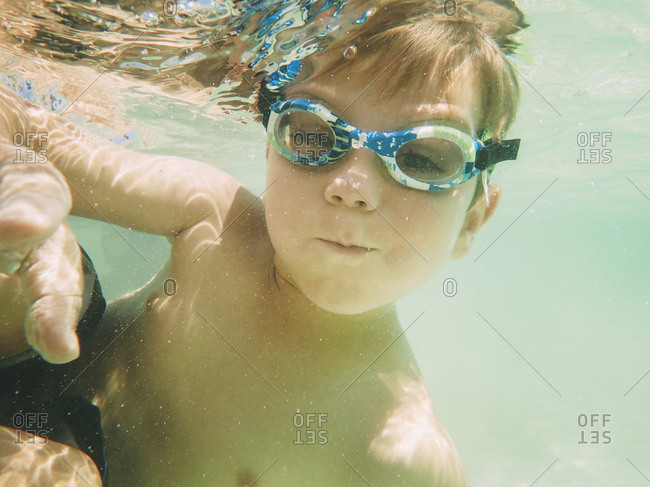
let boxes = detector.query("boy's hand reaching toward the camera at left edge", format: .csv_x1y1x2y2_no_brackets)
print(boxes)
0,155,84,363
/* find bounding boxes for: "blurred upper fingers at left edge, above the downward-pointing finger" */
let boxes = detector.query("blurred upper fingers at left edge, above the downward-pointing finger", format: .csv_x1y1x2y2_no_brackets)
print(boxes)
0,154,72,258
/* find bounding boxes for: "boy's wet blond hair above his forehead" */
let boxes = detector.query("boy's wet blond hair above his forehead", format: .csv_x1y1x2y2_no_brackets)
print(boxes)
306,0,528,140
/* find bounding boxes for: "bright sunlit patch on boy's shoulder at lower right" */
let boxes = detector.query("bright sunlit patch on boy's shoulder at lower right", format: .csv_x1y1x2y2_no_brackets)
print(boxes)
370,370,464,485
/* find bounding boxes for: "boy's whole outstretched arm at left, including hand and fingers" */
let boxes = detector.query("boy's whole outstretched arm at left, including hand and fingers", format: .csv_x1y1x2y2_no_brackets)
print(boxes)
0,87,246,362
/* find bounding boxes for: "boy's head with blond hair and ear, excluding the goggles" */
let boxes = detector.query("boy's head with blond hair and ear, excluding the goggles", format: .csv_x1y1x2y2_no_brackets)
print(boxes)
258,1,522,314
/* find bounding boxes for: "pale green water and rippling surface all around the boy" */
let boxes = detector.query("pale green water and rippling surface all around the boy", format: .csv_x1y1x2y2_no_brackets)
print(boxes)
0,0,650,487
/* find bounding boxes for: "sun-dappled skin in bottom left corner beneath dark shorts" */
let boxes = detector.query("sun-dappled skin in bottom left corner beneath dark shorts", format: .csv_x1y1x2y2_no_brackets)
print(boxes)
0,427,102,487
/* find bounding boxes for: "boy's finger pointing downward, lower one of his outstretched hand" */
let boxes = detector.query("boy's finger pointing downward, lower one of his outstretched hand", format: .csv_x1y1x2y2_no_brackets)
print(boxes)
18,223,84,363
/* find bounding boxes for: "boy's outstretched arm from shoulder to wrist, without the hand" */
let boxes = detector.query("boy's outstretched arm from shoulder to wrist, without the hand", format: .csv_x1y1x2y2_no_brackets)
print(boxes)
0,88,241,235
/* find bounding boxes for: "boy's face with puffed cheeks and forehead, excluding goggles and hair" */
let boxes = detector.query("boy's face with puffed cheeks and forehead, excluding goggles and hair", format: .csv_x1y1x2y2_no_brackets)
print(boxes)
264,63,483,314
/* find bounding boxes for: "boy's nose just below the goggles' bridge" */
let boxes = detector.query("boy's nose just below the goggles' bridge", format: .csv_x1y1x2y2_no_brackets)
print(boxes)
325,149,385,211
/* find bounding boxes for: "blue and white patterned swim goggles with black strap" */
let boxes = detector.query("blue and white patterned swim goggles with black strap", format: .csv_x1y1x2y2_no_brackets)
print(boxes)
266,99,519,191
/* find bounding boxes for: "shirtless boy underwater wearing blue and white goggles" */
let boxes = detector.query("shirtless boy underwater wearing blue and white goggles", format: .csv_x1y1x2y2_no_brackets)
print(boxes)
0,2,523,487
